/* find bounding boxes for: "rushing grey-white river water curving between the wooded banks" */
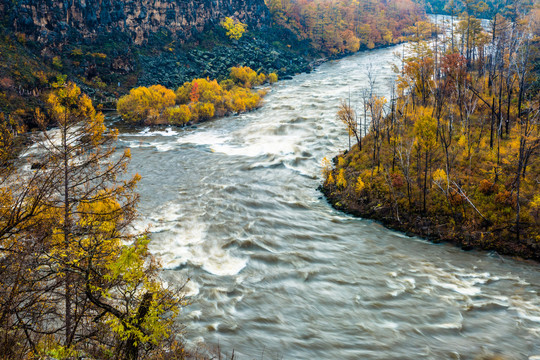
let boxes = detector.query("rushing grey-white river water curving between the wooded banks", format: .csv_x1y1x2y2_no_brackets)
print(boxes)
120,43,540,359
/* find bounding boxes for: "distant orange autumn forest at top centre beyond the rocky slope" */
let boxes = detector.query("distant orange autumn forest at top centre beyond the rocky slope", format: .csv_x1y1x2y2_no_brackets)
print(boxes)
266,0,425,55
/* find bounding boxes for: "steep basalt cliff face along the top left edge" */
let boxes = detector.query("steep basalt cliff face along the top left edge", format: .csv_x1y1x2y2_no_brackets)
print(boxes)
0,0,271,46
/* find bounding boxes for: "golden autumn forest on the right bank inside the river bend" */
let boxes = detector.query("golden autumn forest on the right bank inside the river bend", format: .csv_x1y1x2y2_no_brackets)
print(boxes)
323,6,540,260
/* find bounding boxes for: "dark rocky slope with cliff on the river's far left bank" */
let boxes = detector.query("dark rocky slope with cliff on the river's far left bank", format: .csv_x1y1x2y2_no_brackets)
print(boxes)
0,0,312,114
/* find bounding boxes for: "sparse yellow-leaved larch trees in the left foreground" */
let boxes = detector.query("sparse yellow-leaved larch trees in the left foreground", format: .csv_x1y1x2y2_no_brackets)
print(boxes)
0,83,181,359
